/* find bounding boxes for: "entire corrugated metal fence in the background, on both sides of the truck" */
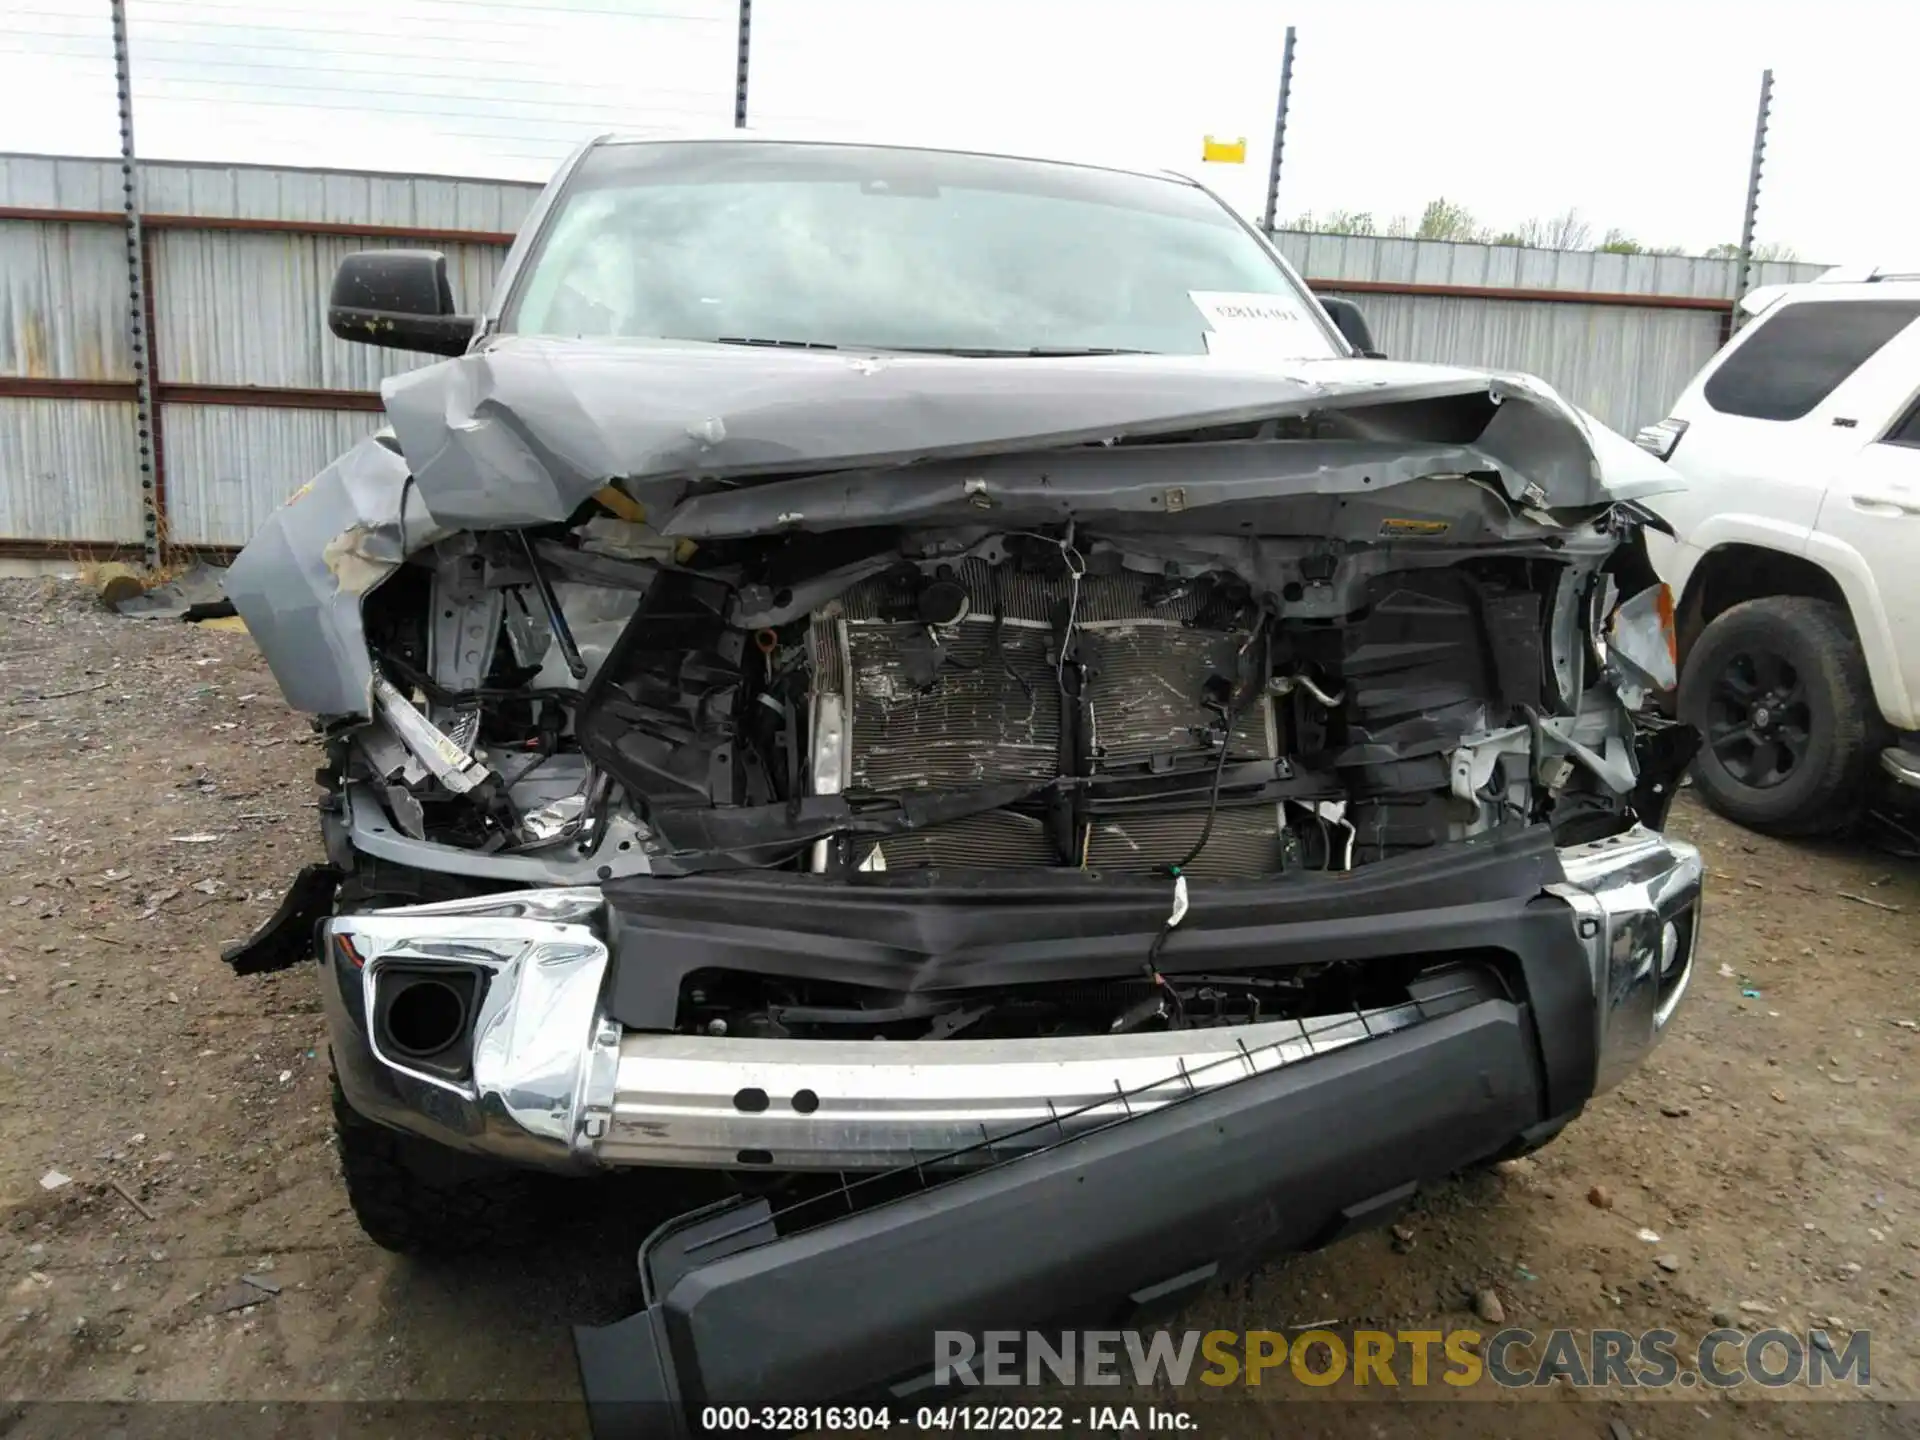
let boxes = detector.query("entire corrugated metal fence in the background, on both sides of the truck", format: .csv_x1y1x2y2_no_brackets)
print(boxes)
0,156,1822,559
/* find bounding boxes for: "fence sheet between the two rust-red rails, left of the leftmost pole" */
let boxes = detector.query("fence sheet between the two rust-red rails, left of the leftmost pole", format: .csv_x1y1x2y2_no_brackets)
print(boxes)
0,221,132,380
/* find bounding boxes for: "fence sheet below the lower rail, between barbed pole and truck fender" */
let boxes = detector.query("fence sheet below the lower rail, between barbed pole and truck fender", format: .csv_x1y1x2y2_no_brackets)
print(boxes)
161,405,380,545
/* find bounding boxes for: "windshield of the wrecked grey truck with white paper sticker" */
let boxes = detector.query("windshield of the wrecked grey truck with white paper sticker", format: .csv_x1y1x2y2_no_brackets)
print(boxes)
501,140,1342,359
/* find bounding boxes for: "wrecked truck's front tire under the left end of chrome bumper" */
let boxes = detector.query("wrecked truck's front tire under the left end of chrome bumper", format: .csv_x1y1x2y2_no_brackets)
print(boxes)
334,1077,541,1256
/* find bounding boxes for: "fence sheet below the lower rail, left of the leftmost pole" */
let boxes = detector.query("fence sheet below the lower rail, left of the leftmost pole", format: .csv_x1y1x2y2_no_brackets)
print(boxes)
0,396,144,543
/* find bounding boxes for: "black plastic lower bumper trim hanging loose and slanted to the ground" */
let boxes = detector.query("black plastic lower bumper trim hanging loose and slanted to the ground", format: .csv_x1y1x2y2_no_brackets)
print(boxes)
576,1000,1548,1440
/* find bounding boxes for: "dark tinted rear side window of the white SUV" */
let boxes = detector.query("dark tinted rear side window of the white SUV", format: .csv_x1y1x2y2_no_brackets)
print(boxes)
1705,300,1920,420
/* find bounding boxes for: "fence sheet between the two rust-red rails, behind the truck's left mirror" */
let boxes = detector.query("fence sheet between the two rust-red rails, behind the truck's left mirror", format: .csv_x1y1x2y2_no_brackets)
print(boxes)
150,230,507,390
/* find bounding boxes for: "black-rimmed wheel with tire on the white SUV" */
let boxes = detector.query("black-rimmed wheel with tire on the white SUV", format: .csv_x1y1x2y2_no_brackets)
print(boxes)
1680,595,1880,835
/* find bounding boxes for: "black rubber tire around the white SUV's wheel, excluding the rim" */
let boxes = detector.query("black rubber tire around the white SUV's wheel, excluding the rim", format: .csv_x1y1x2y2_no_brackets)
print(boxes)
1680,595,1884,837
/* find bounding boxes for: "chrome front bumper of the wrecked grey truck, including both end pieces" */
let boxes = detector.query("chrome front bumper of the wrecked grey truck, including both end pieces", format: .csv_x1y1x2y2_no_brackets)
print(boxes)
321,829,1701,1169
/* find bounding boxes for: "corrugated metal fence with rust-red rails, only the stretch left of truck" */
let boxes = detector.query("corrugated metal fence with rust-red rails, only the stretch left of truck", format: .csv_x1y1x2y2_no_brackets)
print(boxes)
0,156,540,557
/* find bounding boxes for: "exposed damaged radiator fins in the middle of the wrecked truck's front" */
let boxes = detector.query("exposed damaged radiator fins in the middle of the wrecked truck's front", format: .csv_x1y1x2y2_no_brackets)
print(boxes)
814,561,1281,877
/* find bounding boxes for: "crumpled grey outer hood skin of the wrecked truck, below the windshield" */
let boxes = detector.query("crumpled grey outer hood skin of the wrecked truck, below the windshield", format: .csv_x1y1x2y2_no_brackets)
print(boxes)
382,338,1672,530
